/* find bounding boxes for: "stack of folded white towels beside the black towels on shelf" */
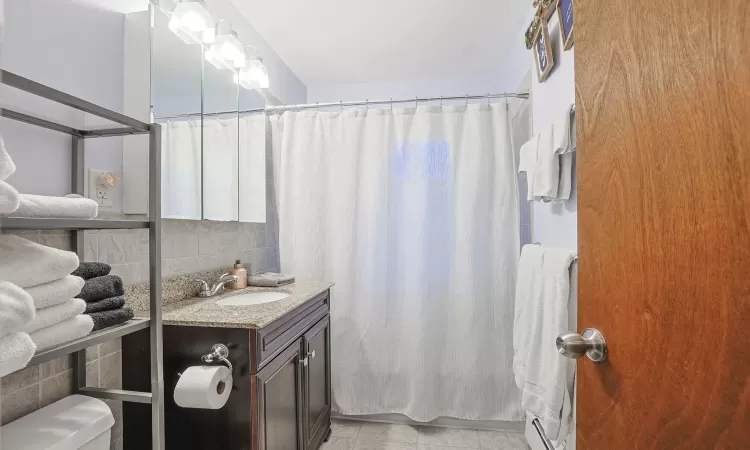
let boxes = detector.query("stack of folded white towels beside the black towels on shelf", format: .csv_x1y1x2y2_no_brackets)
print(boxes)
0,235,94,377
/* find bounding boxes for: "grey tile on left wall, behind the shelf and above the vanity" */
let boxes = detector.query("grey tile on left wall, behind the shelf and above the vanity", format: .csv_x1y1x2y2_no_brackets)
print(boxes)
0,219,279,449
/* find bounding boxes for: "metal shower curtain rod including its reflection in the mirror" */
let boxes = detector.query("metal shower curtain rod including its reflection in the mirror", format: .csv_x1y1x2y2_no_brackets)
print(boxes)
154,92,529,120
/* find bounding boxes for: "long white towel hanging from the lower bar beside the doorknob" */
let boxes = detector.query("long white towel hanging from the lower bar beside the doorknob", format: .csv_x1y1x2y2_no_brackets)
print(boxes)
513,245,575,441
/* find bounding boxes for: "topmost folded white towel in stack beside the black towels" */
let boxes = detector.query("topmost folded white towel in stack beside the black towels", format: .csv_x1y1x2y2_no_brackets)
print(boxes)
0,234,78,288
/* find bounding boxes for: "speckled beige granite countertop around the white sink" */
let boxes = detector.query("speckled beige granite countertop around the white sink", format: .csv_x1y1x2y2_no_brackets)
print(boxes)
132,280,333,328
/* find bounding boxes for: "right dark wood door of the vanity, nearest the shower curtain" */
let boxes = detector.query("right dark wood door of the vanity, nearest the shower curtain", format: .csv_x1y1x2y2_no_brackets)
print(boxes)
303,316,331,450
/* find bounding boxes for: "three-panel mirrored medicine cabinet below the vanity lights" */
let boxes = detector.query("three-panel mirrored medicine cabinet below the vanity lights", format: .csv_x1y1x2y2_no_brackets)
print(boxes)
152,0,268,222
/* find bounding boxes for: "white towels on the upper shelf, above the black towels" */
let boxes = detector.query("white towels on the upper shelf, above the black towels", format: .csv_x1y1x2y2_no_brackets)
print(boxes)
0,137,99,219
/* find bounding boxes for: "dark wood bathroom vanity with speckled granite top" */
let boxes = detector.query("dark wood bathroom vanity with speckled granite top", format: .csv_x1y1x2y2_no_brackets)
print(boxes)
123,282,331,450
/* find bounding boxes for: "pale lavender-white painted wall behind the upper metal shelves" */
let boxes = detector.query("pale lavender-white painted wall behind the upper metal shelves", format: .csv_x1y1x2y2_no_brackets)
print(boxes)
0,0,123,208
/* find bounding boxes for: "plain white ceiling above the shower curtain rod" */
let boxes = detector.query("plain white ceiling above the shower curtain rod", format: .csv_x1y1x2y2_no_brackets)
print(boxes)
231,0,531,86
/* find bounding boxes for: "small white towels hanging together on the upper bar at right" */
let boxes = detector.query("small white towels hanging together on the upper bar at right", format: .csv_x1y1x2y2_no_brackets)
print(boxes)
518,106,576,203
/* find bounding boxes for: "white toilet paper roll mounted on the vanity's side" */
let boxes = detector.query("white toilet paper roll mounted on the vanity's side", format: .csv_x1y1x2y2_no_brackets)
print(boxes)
174,366,232,409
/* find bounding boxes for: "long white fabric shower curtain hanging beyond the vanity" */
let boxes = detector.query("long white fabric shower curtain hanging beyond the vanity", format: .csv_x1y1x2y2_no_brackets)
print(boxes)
271,104,523,421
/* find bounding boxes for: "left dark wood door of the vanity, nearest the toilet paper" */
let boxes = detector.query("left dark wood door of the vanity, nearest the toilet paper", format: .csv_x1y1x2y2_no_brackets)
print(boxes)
256,339,303,450
